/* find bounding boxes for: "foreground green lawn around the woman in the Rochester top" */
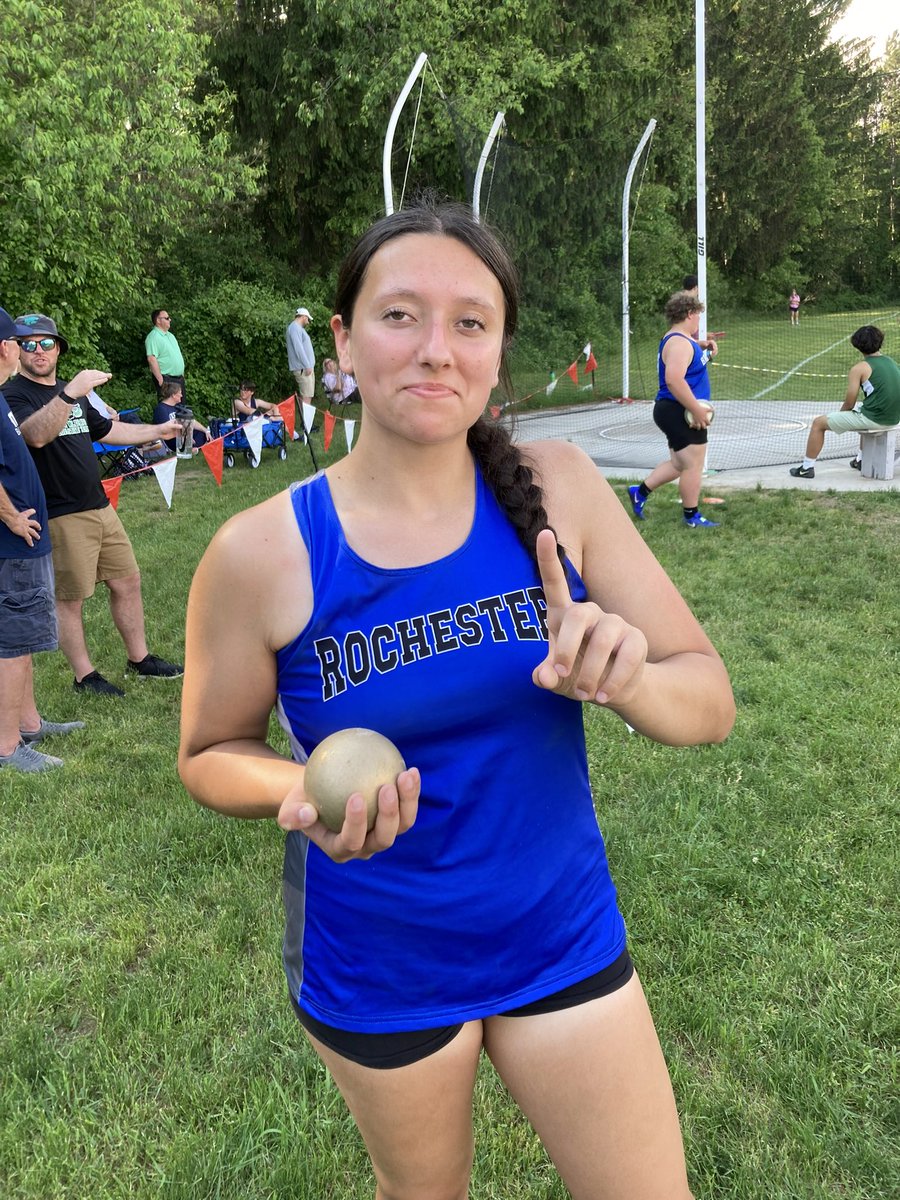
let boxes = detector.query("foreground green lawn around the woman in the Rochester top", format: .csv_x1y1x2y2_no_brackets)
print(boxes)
0,444,900,1200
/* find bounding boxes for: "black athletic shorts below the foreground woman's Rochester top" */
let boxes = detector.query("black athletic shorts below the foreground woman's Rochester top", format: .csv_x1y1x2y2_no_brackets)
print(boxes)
290,950,635,1070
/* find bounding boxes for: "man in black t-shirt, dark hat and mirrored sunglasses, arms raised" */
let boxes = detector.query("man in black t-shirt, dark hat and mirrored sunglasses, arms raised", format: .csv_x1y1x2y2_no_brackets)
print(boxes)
5,313,184,696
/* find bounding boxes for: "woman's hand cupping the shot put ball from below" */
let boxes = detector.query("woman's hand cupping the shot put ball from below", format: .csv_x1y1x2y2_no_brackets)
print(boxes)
278,767,421,863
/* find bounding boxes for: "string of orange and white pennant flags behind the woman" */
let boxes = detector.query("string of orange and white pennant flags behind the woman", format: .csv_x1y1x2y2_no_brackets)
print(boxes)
101,342,607,509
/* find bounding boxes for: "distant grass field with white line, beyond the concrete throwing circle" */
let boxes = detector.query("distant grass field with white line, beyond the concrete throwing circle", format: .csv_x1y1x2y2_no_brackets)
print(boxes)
512,307,900,410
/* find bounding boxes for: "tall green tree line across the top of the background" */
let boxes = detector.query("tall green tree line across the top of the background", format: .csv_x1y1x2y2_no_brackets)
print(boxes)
0,0,900,413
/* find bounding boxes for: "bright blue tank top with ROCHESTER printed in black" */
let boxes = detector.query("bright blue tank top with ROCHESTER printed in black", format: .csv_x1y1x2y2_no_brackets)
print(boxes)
277,472,625,1033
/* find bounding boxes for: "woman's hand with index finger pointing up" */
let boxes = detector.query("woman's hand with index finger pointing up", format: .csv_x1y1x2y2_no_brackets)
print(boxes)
532,529,647,706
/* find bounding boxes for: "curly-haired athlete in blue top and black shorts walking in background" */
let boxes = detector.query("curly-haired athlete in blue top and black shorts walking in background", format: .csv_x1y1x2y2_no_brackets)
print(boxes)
628,292,719,529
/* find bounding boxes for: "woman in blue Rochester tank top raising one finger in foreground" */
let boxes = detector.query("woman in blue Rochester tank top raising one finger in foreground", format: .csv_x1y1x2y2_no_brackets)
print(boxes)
180,206,733,1200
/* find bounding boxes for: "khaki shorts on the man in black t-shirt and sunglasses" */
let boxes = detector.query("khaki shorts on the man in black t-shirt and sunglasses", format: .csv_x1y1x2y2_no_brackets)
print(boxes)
50,504,138,600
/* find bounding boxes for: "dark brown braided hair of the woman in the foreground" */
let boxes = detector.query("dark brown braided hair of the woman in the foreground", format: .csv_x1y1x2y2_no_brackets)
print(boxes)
335,198,563,559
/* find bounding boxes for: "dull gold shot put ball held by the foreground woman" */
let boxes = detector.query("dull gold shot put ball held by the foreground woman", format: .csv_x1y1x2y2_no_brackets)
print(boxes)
304,728,407,833
